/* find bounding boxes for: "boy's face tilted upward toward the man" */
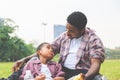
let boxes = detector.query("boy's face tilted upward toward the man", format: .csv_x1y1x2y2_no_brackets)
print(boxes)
39,44,54,60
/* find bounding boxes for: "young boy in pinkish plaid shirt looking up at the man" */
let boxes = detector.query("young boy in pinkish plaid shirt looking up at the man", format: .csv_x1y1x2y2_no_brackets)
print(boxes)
19,43,65,80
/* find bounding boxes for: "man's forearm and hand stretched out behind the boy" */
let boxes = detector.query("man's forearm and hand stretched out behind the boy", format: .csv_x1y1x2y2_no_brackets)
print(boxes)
12,53,36,72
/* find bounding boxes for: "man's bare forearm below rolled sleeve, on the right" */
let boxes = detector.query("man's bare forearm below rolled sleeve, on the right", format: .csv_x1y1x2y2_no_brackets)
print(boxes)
85,58,101,80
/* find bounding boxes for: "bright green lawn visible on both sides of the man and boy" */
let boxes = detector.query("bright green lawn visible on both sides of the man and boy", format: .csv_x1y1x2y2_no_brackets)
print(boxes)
0,58,120,80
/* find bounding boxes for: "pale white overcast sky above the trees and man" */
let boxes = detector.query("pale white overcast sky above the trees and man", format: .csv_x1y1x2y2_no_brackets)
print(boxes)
0,0,120,48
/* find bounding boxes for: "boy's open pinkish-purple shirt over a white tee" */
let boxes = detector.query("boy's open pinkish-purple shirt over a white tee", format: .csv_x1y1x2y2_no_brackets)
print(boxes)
20,58,65,80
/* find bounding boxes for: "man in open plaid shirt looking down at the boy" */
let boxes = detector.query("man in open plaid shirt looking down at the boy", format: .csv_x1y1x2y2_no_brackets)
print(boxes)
13,11,105,80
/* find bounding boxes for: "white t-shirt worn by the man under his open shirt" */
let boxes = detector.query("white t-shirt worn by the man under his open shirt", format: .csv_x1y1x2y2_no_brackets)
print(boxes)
64,37,82,69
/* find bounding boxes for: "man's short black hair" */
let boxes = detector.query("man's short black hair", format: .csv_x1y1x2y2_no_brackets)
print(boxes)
67,11,87,29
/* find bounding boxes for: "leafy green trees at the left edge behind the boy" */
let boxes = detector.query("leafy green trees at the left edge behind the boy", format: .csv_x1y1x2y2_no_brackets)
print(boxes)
0,19,35,61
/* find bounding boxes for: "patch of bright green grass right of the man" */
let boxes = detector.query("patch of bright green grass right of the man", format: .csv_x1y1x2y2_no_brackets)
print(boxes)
100,60,120,80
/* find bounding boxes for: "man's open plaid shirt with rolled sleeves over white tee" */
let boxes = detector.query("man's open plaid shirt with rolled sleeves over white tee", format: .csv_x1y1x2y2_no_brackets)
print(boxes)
52,28,105,70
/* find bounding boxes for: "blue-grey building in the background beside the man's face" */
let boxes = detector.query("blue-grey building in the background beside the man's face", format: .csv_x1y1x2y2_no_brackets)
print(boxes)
53,24,66,39
